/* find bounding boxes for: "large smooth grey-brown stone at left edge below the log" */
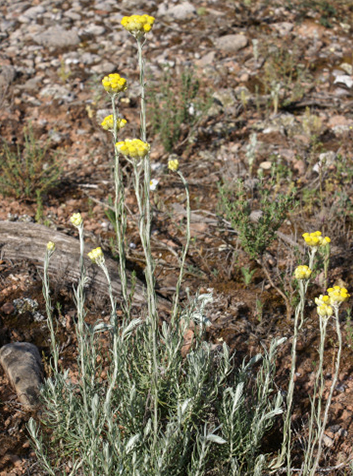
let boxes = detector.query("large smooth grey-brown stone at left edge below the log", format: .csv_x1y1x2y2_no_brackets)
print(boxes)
0,342,43,409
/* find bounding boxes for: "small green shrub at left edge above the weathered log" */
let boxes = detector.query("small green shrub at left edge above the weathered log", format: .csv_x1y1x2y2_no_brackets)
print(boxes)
0,126,62,199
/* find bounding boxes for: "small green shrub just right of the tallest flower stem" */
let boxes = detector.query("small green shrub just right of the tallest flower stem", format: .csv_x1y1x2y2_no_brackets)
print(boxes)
148,68,211,152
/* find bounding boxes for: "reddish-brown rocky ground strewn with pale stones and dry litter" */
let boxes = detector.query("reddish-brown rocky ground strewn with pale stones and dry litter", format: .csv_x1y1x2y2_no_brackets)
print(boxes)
0,0,353,476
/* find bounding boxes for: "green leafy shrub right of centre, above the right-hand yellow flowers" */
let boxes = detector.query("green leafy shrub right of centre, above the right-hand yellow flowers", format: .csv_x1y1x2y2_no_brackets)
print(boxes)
219,180,296,260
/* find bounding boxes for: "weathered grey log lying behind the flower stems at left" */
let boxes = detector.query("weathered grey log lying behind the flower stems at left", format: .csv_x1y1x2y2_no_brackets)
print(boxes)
0,221,170,310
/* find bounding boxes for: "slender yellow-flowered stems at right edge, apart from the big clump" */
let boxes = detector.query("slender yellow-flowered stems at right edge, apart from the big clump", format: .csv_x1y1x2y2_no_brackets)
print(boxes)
272,231,350,476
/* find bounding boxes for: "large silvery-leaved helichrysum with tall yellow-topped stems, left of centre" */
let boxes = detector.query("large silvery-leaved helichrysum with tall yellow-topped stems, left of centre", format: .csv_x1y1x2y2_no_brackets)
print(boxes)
29,15,284,476
